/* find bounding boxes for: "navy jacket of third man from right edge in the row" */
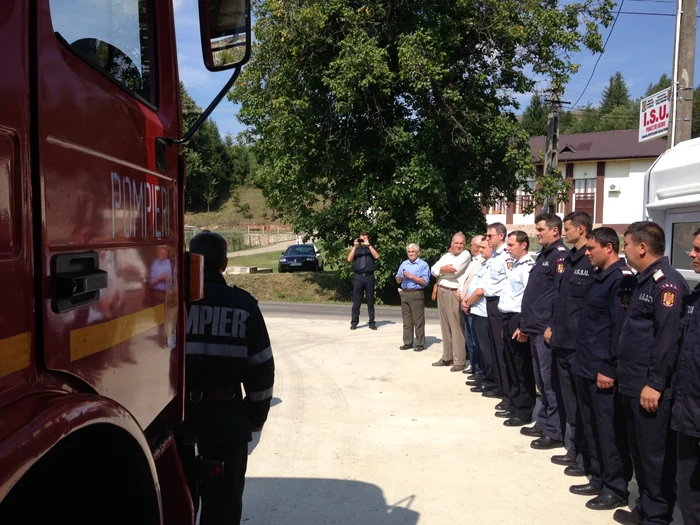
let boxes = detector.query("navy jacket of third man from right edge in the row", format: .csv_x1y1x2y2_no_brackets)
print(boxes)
572,259,637,379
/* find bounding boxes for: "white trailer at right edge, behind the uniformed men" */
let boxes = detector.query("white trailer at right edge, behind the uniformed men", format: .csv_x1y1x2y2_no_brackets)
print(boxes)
644,138,700,286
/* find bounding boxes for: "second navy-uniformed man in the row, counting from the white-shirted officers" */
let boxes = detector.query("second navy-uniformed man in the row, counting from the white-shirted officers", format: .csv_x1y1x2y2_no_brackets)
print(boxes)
544,211,593,476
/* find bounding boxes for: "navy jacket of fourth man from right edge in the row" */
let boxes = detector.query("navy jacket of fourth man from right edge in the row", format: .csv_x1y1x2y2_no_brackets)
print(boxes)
552,246,593,348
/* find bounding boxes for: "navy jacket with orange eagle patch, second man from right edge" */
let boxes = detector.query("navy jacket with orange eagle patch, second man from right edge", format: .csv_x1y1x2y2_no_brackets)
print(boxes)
617,257,688,396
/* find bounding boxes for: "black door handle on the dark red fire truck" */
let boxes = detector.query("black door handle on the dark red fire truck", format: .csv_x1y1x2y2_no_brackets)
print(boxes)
51,250,107,313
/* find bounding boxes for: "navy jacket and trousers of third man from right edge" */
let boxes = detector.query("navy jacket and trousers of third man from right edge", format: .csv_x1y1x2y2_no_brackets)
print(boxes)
573,260,637,501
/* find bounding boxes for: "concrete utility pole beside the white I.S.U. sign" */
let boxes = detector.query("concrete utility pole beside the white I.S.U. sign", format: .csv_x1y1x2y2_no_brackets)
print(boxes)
668,0,697,147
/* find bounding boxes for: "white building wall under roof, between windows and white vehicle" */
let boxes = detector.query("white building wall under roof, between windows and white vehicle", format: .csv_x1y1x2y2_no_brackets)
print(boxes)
603,159,653,224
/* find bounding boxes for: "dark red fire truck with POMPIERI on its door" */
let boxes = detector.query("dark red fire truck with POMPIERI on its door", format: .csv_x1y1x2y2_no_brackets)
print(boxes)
0,0,250,525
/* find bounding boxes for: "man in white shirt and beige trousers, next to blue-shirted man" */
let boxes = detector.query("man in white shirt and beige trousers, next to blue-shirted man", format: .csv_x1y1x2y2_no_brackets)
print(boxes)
431,232,471,372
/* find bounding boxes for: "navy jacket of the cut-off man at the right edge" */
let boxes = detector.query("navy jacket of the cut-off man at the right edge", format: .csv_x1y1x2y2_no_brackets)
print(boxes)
671,285,700,437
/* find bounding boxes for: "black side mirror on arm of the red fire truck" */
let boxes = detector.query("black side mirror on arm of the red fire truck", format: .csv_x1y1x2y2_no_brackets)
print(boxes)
199,0,251,71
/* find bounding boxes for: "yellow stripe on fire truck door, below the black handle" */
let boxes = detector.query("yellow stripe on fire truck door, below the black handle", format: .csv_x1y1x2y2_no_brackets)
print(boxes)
70,304,165,361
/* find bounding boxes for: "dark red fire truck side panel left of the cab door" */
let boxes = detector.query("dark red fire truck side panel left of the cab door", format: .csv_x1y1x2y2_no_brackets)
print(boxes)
0,0,35,393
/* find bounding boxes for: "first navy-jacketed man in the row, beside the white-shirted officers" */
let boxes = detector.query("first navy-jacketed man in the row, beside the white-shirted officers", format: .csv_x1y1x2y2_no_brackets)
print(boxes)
520,213,569,450
